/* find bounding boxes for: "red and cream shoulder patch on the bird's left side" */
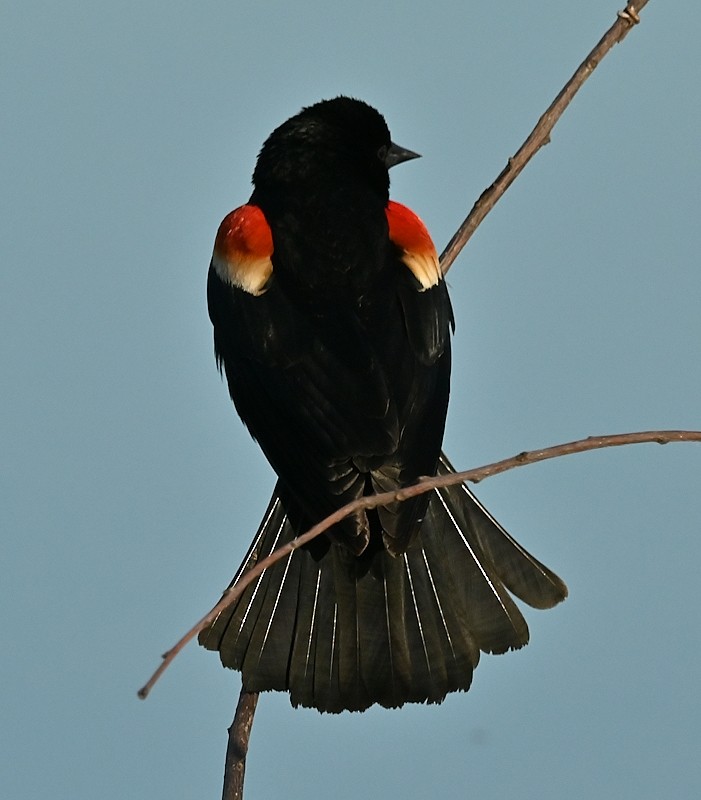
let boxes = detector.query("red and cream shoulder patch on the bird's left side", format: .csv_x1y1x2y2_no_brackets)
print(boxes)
212,205,273,296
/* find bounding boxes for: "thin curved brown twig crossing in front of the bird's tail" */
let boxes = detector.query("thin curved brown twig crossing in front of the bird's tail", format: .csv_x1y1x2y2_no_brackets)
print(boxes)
138,431,701,700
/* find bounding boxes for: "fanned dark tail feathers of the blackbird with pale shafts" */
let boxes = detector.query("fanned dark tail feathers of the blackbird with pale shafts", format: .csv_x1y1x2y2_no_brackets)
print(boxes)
200,456,567,712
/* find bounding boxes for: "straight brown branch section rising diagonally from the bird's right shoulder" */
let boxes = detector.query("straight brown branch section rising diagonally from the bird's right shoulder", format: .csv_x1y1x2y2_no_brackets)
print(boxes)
441,0,648,275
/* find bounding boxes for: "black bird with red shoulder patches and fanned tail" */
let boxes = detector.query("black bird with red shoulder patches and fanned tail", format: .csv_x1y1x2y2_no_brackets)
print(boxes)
200,97,567,712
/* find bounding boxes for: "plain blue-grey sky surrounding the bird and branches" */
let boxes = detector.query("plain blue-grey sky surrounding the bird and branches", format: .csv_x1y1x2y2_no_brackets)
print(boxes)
0,0,701,800
